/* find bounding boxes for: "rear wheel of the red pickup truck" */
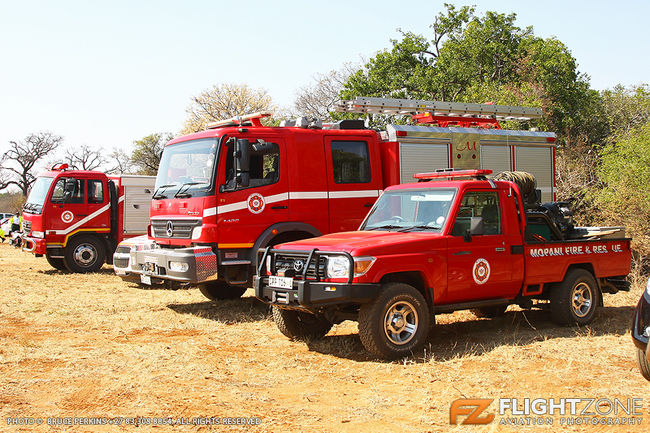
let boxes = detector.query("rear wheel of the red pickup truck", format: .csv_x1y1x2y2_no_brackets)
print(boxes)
550,269,602,326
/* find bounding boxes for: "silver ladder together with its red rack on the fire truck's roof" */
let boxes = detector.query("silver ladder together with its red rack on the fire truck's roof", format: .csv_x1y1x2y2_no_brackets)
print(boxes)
334,96,544,127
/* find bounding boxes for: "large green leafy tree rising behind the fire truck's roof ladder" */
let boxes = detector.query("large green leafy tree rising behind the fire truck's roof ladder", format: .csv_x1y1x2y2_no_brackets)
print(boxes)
341,5,601,144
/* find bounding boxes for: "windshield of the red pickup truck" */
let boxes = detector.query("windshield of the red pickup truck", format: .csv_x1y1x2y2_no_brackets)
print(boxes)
360,189,456,232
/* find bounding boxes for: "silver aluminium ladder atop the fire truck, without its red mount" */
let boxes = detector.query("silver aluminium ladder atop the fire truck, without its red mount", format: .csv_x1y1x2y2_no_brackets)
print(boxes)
334,96,543,120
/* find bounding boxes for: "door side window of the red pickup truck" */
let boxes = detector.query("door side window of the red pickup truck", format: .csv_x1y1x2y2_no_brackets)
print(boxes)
451,191,501,236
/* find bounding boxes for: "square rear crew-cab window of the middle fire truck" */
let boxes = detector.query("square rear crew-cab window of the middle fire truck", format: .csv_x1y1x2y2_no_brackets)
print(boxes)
332,141,370,183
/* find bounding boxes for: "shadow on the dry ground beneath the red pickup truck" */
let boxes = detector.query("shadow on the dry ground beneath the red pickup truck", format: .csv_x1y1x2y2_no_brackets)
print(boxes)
306,306,634,363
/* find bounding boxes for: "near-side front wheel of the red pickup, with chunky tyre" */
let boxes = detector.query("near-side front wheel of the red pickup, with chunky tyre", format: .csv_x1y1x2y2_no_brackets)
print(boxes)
359,283,431,359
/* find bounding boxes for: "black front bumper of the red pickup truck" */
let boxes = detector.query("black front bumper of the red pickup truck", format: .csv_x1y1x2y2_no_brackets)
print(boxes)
253,276,381,311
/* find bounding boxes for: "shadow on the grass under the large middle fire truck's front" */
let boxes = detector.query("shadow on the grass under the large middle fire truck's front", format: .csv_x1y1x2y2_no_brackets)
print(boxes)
167,296,271,323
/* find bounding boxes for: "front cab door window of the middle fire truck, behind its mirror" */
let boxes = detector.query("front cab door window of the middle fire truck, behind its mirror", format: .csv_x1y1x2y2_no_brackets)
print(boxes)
226,139,280,188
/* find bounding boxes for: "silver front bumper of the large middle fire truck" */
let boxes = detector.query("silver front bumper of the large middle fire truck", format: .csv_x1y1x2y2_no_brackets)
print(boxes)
113,247,217,284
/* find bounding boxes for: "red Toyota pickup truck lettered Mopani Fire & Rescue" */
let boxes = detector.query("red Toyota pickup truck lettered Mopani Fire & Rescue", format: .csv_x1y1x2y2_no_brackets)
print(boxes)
254,170,631,358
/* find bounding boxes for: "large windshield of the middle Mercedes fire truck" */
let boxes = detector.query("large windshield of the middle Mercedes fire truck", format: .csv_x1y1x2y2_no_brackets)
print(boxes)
153,138,218,200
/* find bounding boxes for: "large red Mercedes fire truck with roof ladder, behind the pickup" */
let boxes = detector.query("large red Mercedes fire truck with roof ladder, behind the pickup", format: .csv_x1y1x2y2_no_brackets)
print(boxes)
114,98,555,299
